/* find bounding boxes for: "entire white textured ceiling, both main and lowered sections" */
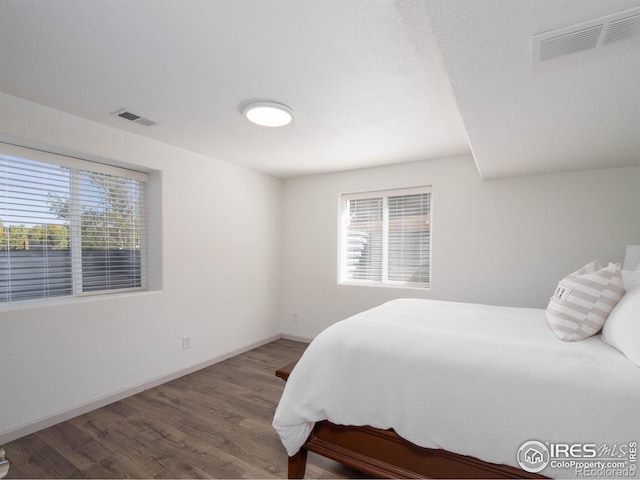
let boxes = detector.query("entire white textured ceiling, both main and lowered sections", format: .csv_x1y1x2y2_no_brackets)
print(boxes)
0,0,640,178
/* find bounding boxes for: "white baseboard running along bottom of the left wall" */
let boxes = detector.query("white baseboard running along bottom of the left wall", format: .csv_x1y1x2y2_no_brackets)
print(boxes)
0,335,282,446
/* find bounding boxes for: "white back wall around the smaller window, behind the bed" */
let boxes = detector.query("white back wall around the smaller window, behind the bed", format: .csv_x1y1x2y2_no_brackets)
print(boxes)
282,156,640,338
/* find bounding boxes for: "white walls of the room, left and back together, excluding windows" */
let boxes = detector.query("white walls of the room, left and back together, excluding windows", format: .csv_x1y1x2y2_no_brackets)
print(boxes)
0,90,640,444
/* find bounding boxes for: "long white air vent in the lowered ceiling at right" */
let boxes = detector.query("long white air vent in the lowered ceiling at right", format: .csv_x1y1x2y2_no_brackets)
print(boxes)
531,7,640,65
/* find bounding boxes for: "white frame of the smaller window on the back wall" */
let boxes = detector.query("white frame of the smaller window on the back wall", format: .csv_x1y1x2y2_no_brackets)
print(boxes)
338,185,433,291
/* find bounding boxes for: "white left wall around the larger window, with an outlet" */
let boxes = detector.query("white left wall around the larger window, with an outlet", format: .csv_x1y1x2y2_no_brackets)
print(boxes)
0,94,282,444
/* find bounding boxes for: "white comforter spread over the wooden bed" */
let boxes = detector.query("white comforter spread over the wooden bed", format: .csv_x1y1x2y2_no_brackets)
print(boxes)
273,299,640,476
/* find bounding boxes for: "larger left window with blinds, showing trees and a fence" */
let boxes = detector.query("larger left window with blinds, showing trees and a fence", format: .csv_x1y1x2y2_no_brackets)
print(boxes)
0,143,148,302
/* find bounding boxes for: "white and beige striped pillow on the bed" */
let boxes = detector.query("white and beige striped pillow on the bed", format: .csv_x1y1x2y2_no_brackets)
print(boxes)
547,261,624,342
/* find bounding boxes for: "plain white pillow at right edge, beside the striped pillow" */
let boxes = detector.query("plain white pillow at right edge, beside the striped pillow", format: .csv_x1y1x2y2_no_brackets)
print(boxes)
602,288,640,367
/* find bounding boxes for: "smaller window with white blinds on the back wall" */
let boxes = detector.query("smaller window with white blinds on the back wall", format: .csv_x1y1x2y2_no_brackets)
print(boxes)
340,187,431,287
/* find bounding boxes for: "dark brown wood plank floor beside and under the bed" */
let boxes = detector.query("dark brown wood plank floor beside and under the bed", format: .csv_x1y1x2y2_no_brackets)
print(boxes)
4,340,358,478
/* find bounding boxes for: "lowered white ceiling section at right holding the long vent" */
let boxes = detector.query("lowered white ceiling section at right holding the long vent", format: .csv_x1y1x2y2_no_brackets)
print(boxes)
425,0,640,178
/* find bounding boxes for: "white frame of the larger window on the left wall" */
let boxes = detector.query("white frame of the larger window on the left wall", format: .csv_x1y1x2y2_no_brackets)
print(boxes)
0,141,150,308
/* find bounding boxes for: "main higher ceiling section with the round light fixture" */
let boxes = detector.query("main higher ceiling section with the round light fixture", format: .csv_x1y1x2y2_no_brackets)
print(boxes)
0,0,469,177
